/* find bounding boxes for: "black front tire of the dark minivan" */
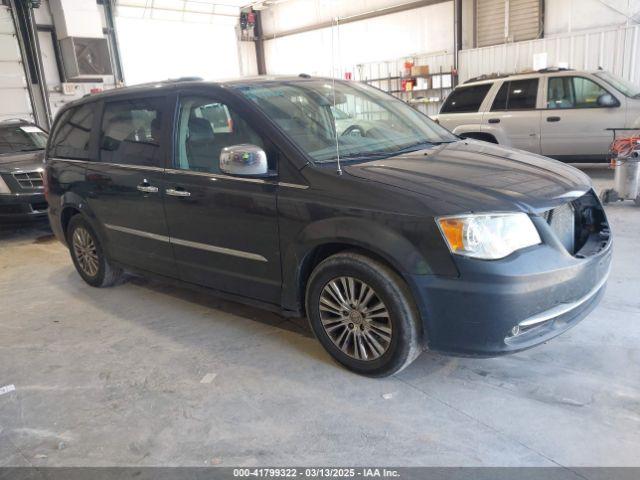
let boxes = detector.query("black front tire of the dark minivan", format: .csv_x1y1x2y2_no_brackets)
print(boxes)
306,252,423,377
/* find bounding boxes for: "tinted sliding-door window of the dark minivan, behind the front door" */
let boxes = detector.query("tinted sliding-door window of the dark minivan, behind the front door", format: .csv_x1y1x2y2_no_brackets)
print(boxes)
100,98,164,167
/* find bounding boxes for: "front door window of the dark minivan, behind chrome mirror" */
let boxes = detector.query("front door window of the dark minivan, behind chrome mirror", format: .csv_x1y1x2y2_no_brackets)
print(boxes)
176,96,264,173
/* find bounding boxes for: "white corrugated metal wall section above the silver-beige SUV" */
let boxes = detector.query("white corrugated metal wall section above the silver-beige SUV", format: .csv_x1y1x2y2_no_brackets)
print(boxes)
459,25,640,84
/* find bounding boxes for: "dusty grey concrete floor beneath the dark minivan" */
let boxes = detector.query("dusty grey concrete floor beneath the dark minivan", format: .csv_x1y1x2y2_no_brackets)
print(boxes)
0,170,640,466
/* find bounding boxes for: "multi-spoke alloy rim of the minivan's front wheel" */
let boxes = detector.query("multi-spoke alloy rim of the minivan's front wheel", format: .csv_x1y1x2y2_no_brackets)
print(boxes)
320,277,392,361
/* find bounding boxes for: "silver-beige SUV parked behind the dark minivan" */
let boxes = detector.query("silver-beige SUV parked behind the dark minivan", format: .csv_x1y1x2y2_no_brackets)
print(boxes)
437,69,640,162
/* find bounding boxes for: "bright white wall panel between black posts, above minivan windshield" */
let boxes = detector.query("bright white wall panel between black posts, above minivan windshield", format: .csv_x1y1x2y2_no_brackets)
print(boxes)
265,2,453,76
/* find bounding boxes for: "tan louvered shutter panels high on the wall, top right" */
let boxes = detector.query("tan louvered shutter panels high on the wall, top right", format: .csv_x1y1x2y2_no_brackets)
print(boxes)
476,0,542,47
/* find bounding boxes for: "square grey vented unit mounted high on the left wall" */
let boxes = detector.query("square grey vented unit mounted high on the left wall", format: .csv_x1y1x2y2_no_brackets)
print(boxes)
60,37,113,80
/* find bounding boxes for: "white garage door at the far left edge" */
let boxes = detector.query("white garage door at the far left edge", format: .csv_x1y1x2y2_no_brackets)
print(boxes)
0,5,33,121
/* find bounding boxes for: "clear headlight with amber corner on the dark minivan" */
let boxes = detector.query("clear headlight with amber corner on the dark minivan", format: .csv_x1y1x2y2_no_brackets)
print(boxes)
436,213,541,260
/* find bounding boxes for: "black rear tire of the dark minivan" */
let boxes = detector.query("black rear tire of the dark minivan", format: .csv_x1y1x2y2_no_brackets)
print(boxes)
67,215,122,287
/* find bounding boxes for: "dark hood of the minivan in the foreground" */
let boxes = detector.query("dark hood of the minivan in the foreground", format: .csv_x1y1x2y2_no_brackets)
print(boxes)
344,140,591,215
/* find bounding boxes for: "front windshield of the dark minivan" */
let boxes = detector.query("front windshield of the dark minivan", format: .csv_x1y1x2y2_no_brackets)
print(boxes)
238,79,458,163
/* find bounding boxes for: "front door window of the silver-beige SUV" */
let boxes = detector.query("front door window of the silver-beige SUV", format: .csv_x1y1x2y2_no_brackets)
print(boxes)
547,77,608,108
